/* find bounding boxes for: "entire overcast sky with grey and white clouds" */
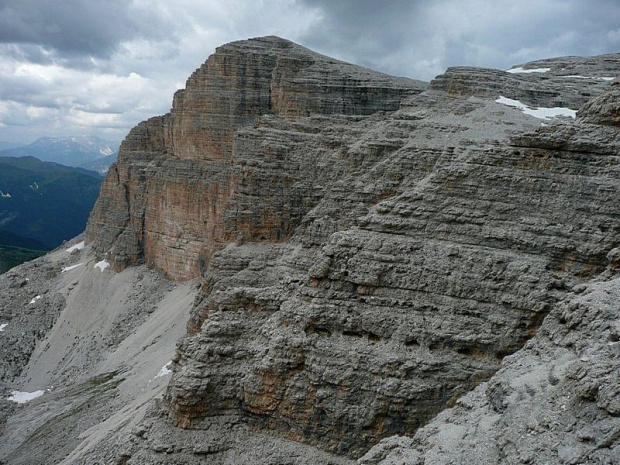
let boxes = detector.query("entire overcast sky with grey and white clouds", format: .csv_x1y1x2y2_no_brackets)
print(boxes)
0,0,620,142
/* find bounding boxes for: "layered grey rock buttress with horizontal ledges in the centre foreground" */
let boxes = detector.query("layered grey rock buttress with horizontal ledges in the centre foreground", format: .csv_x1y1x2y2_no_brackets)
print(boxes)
165,82,619,456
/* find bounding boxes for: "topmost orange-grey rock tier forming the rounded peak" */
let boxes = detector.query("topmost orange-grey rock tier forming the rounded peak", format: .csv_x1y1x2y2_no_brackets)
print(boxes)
170,37,425,161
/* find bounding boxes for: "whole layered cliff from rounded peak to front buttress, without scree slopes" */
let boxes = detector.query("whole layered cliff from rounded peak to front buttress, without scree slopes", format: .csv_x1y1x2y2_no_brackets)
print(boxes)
83,38,620,463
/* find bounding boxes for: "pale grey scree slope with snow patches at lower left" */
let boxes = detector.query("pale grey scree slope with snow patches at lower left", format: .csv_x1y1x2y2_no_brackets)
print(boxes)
0,238,198,465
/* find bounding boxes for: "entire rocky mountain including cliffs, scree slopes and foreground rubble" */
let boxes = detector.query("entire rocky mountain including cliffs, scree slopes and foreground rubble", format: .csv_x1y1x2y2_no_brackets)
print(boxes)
0,37,620,464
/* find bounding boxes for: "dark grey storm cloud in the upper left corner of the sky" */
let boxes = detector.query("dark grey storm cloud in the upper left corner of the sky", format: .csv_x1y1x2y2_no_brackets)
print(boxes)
0,0,171,60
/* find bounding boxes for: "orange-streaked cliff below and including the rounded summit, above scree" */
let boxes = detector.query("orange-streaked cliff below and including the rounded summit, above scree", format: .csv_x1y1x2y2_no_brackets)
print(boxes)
88,37,425,279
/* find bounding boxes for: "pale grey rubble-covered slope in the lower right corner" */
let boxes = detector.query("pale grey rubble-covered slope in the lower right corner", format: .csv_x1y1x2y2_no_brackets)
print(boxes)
359,277,620,465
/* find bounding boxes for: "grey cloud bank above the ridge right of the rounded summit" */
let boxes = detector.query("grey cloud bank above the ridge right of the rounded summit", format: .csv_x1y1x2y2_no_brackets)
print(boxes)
299,0,620,79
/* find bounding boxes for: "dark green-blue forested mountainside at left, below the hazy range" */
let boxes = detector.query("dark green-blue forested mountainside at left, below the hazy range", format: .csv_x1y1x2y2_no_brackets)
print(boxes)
0,157,102,272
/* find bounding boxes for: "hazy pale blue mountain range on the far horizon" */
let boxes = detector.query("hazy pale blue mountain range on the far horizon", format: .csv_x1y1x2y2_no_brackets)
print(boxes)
0,136,119,174
